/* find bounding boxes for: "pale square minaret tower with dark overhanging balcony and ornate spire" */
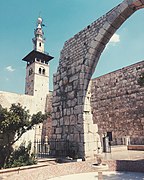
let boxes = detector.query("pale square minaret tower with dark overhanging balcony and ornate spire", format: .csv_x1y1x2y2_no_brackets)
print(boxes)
23,17,53,109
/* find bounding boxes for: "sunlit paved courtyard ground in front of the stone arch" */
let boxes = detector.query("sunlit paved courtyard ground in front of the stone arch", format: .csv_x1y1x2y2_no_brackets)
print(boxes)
0,146,144,180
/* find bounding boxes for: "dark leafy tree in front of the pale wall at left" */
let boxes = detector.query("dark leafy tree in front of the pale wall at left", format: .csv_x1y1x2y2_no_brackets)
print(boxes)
0,104,48,168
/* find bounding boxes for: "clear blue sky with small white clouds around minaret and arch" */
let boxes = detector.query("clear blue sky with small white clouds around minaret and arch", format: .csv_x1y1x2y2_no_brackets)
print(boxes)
0,0,144,94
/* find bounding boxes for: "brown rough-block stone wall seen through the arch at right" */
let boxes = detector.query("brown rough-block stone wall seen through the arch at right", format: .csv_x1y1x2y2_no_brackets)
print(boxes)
91,61,144,144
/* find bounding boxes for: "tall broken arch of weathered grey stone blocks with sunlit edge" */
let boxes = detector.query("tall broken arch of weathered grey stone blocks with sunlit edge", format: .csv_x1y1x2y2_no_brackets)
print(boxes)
51,0,144,158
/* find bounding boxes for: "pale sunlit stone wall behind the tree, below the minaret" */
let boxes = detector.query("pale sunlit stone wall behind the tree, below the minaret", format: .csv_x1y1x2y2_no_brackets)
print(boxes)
0,91,52,146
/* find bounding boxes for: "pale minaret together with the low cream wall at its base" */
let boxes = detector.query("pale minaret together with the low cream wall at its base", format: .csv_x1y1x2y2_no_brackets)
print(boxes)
0,17,53,144
